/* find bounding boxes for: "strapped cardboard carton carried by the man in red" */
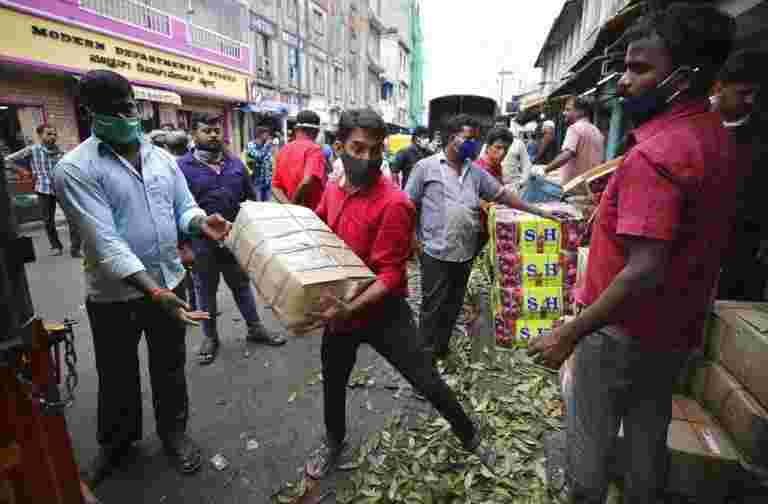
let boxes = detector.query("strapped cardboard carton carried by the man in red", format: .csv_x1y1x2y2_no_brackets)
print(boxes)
225,202,376,334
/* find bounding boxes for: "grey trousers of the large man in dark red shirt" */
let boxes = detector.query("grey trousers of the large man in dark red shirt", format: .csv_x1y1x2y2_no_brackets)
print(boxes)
566,327,688,504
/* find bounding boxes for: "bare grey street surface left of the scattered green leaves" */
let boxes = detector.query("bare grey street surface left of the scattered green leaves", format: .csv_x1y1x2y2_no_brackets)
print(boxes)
26,227,425,504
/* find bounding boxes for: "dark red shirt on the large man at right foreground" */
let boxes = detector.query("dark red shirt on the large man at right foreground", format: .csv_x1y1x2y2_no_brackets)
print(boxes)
583,101,746,351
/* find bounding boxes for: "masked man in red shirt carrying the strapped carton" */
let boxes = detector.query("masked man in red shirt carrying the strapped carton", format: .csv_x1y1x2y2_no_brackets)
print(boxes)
306,109,495,479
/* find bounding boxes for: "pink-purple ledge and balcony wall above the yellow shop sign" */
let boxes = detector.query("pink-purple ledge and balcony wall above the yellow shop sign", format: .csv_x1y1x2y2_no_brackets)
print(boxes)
0,0,251,73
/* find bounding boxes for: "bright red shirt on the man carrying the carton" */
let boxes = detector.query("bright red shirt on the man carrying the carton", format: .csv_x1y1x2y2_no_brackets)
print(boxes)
317,177,416,328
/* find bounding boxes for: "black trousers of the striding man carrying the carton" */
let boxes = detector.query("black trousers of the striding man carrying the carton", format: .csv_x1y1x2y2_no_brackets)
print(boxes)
321,297,475,445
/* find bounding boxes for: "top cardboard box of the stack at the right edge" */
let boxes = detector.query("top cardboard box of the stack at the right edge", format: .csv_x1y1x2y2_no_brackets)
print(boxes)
707,305,768,407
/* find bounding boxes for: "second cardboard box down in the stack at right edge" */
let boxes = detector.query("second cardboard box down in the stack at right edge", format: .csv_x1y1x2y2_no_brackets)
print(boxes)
693,363,768,467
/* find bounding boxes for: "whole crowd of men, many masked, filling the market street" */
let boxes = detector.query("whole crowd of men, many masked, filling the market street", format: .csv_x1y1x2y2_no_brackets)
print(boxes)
6,4,768,503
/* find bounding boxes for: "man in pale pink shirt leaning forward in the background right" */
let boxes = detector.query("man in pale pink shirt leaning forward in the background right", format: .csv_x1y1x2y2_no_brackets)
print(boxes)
544,97,605,185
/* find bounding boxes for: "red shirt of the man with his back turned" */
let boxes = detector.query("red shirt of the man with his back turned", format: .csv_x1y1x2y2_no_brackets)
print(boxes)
272,139,328,210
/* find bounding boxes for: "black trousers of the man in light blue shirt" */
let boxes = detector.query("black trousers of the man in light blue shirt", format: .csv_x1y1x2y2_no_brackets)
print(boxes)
86,288,189,446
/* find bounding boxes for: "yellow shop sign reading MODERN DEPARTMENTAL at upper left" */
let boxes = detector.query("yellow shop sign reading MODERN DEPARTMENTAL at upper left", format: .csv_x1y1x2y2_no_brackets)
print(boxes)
0,9,247,101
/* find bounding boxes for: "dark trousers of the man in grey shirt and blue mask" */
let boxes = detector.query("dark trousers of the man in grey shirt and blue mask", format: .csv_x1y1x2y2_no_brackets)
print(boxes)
420,254,473,357
